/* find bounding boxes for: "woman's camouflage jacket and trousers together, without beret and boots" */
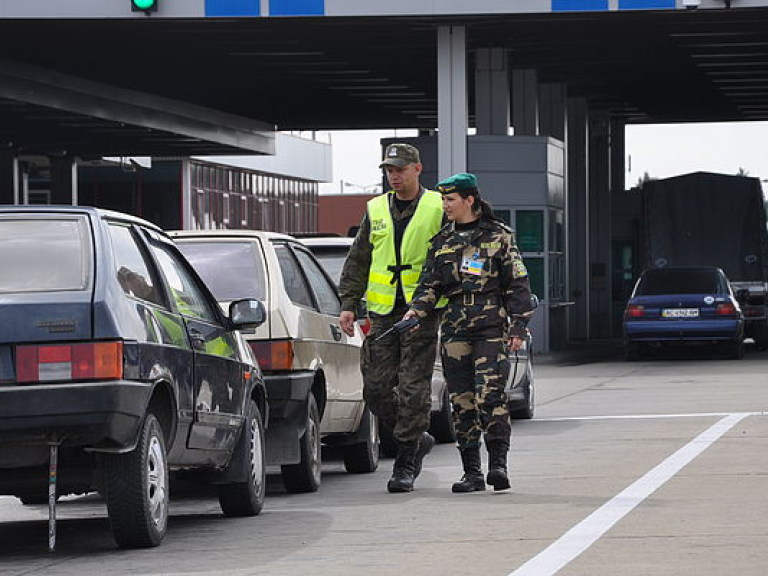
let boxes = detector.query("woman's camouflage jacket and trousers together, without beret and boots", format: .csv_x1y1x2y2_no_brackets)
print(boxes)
411,218,533,450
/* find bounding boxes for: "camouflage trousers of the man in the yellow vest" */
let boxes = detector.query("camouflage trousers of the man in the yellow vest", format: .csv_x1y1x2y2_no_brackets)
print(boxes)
360,308,438,442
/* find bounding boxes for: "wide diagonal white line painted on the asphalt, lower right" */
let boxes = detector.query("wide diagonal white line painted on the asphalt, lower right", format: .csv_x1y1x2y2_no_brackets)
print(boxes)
509,413,752,576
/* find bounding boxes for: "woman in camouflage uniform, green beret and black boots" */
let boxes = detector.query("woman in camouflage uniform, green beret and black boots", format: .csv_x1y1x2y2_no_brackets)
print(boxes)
405,173,533,492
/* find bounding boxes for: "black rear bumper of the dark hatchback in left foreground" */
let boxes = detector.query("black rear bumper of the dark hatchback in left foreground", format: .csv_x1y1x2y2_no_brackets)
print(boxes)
0,380,152,450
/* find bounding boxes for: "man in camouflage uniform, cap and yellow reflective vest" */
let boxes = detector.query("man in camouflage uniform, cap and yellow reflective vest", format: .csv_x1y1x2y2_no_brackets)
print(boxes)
339,144,443,492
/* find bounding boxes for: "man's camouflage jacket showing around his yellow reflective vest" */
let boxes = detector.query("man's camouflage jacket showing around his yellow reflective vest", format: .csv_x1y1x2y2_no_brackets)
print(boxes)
339,186,440,314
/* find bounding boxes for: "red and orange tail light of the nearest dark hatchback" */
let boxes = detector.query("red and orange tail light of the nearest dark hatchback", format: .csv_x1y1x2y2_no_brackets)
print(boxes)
16,341,123,382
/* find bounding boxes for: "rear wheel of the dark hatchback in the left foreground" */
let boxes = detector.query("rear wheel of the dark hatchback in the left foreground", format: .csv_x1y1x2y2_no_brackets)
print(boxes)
104,413,168,548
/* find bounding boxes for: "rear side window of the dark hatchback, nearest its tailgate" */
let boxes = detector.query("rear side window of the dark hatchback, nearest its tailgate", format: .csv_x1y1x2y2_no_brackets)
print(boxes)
109,223,165,306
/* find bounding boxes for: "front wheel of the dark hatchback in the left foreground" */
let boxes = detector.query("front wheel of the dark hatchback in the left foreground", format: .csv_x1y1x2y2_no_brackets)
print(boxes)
218,400,266,516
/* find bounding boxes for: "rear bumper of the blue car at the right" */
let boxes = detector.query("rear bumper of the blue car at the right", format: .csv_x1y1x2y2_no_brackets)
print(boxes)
624,319,744,342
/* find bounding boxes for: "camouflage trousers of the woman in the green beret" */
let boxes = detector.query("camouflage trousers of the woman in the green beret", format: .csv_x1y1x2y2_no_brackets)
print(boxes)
440,335,512,450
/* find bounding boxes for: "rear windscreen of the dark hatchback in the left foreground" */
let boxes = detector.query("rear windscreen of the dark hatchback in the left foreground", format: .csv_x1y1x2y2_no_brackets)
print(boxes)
0,216,91,294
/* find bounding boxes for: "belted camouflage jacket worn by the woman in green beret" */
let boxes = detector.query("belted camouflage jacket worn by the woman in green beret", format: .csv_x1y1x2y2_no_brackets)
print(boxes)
411,218,533,336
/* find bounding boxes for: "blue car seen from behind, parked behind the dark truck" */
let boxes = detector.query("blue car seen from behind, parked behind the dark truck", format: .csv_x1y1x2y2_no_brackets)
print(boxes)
624,266,744,360
